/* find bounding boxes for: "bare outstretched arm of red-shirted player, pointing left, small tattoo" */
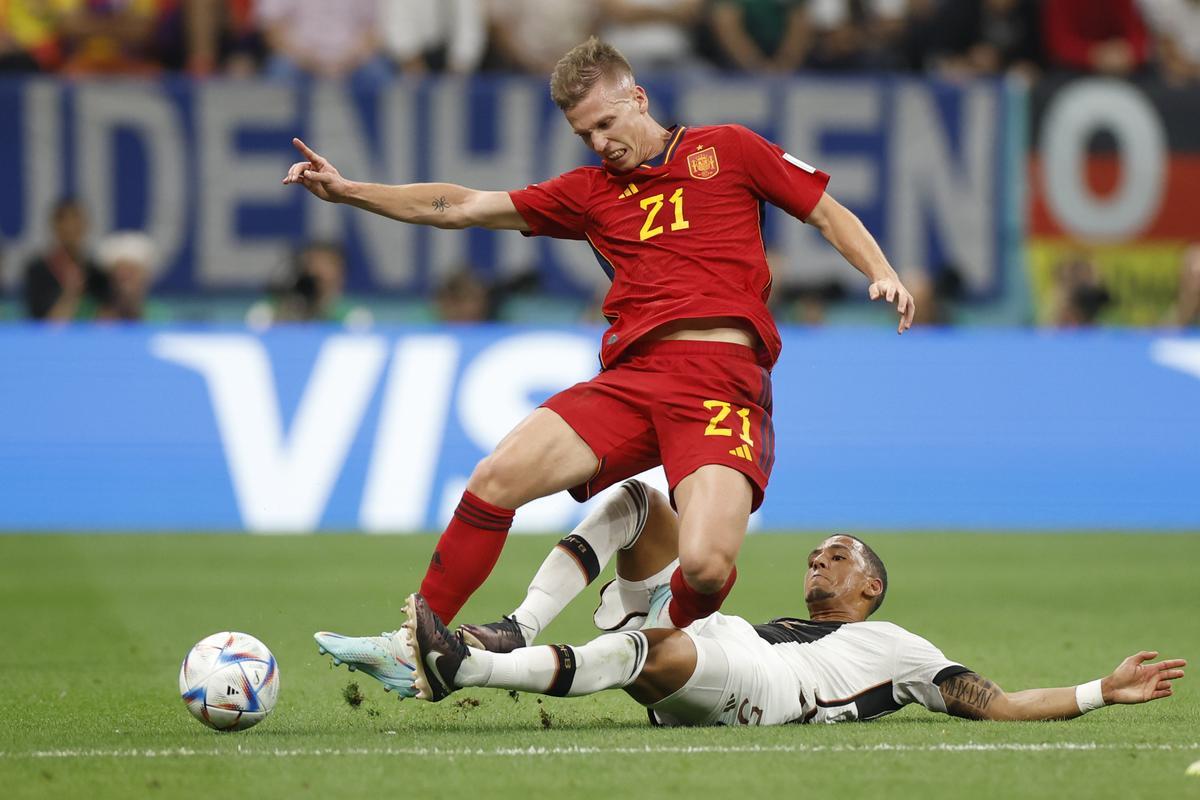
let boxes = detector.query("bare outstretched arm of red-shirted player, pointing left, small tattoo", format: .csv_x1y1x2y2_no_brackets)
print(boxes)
283,139,529,230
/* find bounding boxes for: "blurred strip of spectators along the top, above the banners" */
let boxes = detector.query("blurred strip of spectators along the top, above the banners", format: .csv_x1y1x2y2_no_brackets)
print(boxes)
9,0,1200,83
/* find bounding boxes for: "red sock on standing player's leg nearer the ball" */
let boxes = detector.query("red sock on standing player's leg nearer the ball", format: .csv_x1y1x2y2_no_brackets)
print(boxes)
421,492,514,625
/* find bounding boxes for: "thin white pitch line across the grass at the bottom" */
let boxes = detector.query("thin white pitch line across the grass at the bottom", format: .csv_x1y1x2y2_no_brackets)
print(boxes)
0,741,1200,759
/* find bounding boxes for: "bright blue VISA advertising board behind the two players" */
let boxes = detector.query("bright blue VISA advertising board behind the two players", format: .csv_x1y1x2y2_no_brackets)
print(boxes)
0,326,1200,533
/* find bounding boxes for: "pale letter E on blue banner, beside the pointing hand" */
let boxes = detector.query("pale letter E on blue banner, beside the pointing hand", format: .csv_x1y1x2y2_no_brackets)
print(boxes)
199,80,296,289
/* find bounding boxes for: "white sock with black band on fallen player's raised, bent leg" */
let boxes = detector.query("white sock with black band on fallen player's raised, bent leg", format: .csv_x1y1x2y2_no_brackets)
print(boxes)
512,481,649,644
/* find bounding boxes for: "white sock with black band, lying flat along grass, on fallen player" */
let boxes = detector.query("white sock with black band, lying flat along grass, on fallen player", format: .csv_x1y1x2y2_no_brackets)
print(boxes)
455,631,649,697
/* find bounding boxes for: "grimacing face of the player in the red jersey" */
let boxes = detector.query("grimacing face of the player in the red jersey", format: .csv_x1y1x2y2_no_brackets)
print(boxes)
566,78,653,172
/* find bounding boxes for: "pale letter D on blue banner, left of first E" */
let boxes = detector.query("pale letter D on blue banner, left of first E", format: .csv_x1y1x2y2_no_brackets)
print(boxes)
76,82,184,263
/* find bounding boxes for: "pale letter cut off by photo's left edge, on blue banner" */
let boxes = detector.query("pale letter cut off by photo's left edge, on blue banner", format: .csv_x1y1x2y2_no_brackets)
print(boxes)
0,79,62,287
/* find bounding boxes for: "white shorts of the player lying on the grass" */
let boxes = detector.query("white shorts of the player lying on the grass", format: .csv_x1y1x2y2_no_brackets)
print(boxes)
649,614,804,727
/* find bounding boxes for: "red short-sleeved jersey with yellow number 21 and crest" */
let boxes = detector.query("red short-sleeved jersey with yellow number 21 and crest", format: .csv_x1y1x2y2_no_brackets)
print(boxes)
509,125,829,368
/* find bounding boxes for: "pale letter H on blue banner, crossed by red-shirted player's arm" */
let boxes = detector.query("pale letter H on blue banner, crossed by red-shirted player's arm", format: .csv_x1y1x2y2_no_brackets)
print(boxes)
424,79,532,283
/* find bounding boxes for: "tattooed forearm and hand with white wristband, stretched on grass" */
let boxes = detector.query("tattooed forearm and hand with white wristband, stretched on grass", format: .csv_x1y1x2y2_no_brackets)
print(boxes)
941,650,1187,721
